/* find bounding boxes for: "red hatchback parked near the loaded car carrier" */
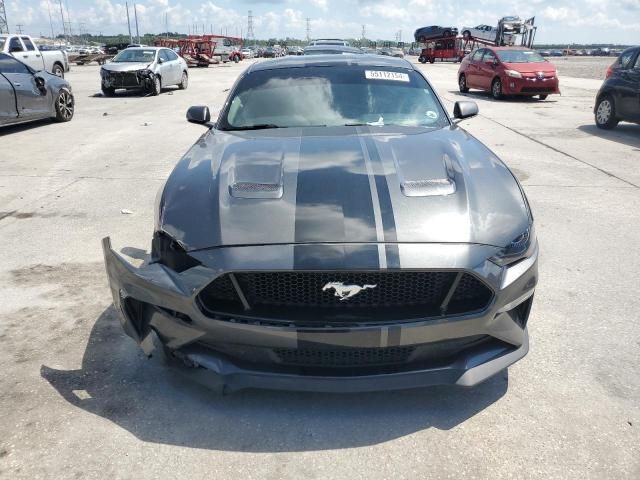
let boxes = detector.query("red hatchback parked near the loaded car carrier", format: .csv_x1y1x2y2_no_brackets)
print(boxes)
458,47,560,100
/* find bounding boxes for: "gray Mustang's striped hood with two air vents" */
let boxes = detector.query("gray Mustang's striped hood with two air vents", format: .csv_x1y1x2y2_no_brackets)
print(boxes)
157,126,529,250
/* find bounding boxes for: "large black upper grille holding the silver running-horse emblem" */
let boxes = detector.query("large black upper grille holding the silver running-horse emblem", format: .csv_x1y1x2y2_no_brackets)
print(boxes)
199,271,493,323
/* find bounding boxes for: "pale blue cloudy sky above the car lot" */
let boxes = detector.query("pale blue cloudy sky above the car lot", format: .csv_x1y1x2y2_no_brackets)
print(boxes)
5,0,640,44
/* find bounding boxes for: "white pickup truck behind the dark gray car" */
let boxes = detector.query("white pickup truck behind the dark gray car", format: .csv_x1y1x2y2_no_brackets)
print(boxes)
0,34,69,78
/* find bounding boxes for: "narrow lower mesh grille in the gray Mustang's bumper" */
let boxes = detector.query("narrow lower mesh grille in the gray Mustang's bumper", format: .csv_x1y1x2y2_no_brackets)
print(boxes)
273,347,415,367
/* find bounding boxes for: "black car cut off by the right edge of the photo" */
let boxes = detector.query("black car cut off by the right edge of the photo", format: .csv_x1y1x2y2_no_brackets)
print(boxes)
593,46,640,129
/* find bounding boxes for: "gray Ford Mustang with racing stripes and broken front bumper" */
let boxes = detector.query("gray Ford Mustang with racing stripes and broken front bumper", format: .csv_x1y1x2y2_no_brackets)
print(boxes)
103,55,538,391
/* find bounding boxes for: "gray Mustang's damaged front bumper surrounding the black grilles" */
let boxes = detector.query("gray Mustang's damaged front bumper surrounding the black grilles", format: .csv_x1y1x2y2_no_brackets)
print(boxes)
103,238,537,392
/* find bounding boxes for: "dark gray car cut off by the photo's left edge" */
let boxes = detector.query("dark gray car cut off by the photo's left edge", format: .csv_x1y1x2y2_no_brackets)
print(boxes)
0,53,75,126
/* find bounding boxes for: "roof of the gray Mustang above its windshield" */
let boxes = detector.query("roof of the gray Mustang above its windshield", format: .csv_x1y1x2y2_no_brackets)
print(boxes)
249,54,415,72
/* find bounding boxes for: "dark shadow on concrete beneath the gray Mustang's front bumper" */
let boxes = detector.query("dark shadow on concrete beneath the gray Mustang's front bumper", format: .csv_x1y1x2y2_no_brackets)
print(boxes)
40,306,508,452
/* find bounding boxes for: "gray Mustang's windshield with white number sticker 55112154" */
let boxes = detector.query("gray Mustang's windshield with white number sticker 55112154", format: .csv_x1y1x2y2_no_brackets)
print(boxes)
220,66,449,130
